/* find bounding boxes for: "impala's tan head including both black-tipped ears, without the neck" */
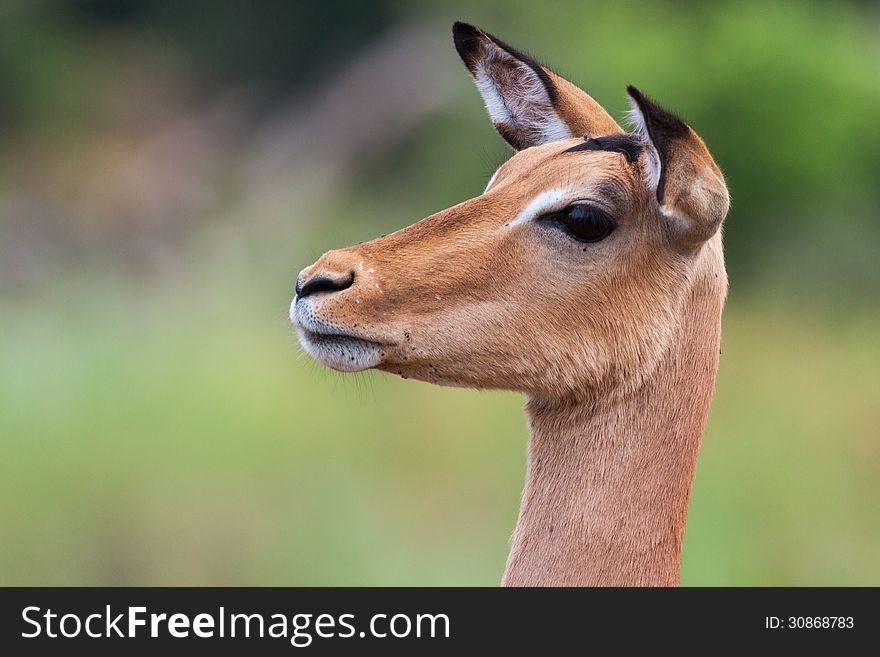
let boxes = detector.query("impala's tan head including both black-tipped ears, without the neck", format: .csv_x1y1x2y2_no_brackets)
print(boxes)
290,23,728,398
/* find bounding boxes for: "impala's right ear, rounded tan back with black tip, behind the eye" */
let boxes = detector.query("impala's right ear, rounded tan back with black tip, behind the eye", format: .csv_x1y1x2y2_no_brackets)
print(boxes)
626,86,730,246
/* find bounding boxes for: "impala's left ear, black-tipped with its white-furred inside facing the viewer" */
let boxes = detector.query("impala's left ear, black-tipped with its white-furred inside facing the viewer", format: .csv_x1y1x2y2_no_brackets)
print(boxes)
452,23,623,150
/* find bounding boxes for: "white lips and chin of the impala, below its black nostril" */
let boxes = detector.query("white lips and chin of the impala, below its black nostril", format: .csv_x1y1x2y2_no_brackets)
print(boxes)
290,298,383,372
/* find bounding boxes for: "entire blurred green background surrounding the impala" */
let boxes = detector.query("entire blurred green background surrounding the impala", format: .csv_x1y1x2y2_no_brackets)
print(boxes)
0,0,880,585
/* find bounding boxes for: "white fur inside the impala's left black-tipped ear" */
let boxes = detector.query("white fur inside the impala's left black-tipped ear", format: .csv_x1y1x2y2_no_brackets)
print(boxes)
474,47,572,145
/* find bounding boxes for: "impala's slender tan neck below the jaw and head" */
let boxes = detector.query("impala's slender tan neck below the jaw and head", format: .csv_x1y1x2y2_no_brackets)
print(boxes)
503,266,723,586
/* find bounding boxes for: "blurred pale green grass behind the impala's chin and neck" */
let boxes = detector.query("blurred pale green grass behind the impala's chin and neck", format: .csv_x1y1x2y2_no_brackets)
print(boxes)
0,272,880,585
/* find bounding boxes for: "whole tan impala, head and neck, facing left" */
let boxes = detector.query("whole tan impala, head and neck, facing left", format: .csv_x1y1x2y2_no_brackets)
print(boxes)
290,23,729,586
